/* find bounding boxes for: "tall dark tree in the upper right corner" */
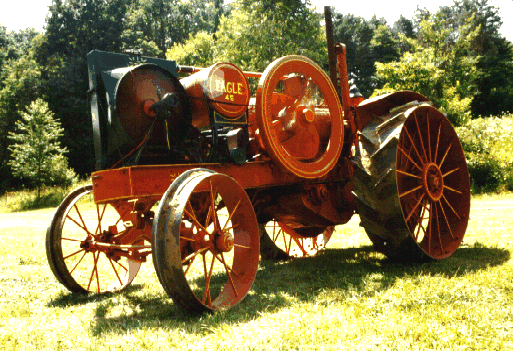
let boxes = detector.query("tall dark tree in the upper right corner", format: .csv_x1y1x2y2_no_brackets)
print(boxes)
417,0,513,117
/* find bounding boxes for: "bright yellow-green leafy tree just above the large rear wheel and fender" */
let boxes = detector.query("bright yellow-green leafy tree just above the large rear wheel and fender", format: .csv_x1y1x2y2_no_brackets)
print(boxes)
374,13,478,125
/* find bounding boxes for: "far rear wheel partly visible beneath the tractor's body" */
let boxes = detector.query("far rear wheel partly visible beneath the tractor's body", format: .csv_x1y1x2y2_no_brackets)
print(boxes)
265,221,335,258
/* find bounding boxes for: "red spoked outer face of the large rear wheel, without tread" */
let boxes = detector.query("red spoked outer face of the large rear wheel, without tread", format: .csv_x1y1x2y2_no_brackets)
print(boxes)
396,106,470,258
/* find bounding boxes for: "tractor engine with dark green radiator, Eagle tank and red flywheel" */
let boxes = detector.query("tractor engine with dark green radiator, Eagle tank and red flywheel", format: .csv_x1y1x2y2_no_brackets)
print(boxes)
88,51,354,237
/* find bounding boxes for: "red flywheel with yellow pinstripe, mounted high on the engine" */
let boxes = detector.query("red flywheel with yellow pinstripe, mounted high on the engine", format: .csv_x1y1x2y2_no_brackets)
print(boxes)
256,56,344,182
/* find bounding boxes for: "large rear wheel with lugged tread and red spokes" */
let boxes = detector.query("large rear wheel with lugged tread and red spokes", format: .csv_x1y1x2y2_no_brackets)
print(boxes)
354,102,470,260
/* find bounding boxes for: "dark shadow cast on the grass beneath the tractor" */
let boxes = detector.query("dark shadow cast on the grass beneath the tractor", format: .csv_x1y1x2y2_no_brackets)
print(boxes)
63,244,504,336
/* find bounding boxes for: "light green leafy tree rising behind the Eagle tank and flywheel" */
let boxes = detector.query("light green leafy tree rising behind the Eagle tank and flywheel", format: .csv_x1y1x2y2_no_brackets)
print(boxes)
170,1,327,71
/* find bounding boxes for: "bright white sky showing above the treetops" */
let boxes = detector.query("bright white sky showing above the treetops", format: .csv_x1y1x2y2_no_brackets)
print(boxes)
0,0,513,42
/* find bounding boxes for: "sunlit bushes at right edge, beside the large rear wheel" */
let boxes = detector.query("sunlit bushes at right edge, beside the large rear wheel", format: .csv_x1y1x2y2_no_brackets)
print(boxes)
456,115,513,192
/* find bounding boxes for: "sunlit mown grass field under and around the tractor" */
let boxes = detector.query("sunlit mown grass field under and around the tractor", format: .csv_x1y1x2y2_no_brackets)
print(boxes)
0,194,513,350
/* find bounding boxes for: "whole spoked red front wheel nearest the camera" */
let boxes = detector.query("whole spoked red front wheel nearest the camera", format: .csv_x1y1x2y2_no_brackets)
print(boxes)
154,170,259,312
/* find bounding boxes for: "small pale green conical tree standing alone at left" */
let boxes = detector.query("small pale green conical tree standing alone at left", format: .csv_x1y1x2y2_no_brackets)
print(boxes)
8,100,75,198
